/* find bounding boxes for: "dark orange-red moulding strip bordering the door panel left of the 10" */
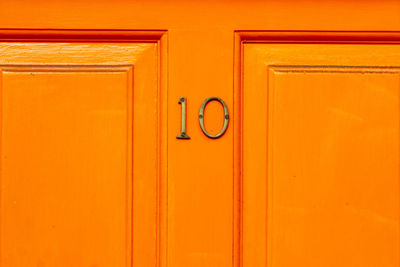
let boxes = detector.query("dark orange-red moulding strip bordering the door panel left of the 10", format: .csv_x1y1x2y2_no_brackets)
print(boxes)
0,28,168,267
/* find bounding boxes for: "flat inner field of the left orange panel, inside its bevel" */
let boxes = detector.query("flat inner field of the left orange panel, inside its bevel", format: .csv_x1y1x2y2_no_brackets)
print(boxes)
1,68,132,266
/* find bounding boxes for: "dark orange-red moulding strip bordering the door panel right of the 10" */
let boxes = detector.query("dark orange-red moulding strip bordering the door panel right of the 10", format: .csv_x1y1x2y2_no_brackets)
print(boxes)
232,30,400,267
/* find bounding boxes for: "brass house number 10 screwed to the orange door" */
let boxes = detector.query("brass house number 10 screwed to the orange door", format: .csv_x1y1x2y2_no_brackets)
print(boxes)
176,96,229,139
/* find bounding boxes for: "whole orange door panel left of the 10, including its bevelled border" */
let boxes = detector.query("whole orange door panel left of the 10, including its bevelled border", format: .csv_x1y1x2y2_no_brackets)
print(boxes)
0,40,159,267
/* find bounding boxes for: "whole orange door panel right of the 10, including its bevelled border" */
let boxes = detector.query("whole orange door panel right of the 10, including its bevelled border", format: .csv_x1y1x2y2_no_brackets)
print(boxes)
242,43,400,267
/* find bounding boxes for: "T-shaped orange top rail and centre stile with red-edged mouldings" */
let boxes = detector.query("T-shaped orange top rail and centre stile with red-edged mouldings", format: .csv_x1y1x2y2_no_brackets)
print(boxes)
0,0,400,267
